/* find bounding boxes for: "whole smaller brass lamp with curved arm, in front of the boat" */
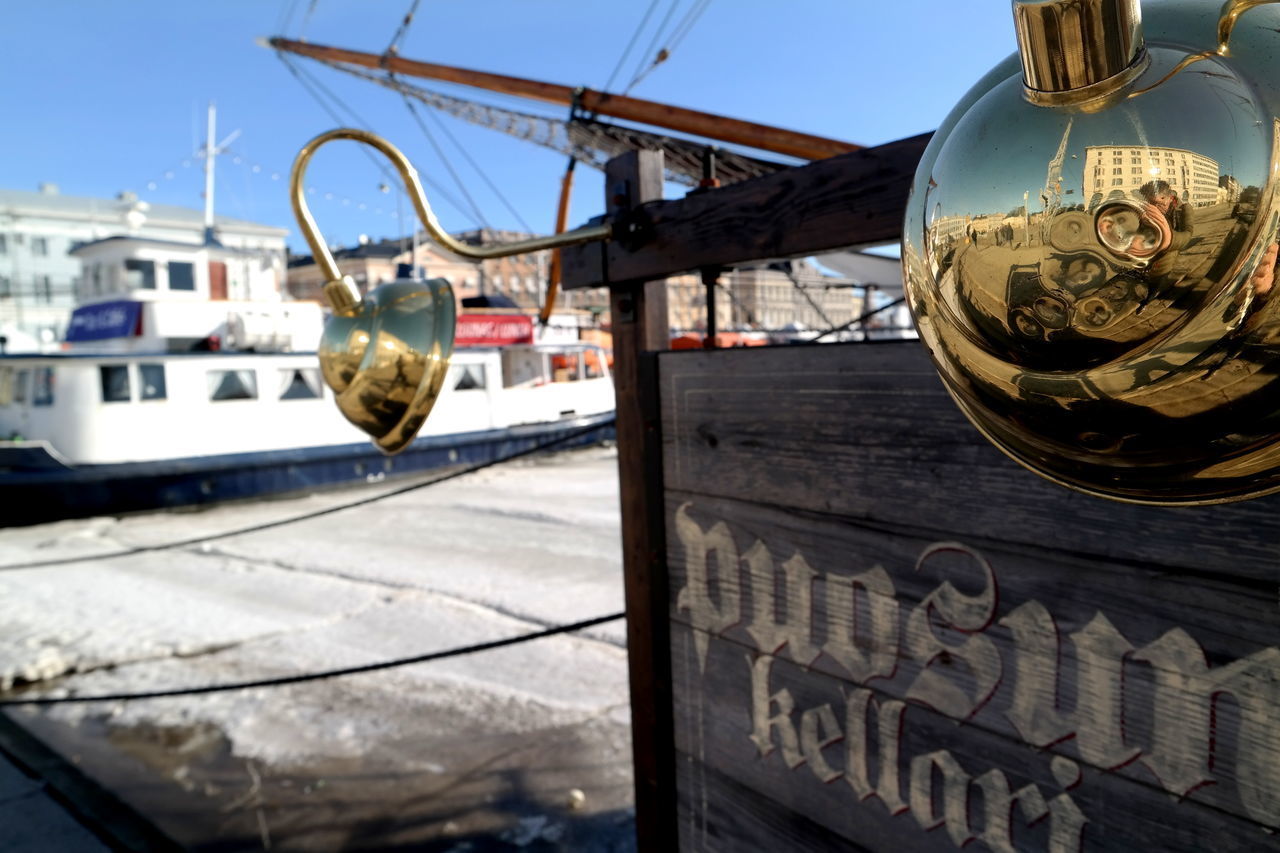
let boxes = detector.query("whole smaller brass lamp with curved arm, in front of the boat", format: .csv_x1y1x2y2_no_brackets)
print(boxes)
289,128,612,453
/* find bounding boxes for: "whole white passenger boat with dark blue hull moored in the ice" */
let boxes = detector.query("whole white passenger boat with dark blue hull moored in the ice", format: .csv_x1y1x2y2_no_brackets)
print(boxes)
0,238,614,524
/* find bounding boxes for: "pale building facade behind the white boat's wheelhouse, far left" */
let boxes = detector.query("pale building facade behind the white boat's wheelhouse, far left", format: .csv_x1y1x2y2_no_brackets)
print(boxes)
0,184,288,352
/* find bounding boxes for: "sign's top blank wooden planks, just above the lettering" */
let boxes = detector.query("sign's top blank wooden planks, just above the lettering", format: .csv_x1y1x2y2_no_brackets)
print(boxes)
660,342,1280,581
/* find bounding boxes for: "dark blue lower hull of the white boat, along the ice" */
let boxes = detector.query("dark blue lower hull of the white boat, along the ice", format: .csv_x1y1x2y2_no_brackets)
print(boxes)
0,412,614,526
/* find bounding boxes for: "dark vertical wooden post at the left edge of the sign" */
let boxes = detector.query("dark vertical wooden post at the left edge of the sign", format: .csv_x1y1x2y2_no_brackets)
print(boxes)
604,151,676,850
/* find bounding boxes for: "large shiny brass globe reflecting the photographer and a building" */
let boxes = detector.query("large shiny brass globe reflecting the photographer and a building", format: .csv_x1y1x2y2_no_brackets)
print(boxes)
902,0,1280,503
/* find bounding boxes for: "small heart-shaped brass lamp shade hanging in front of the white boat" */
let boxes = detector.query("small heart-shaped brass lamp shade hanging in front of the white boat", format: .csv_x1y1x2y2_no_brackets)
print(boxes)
319,278,457,453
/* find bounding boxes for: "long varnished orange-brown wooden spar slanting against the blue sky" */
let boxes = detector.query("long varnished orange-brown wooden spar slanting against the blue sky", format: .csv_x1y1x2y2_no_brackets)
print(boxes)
269,37,861,160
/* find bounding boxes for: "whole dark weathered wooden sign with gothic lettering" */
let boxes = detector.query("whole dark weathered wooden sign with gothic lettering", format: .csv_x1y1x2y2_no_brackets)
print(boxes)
657,342,1280,853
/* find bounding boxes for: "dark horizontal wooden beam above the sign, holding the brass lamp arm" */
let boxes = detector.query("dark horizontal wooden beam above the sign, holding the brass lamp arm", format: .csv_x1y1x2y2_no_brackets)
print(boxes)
562,133,932,289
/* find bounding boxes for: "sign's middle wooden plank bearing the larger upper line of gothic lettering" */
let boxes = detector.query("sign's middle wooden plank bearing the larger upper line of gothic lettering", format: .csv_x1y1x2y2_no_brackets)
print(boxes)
668,494,1280,826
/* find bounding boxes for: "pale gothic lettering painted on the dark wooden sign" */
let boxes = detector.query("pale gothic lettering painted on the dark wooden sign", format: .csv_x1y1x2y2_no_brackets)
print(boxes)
673,503,1280,853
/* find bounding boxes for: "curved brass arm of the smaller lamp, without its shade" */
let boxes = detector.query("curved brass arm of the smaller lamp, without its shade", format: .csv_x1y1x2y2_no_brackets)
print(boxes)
289,127,613,314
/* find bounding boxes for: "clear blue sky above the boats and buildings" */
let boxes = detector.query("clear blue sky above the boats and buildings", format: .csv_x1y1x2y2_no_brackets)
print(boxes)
0,0,1015,248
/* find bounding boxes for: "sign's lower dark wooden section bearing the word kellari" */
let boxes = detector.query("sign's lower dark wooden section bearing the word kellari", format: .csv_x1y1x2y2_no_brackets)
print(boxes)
673,617,1276,853
